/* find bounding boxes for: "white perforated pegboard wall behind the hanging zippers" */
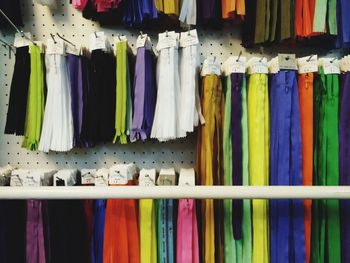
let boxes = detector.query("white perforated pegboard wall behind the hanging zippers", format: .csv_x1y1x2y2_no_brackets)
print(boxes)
0,0,344,170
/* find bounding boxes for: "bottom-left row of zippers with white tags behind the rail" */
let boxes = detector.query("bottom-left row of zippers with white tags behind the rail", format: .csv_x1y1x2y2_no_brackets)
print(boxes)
0,164,199,263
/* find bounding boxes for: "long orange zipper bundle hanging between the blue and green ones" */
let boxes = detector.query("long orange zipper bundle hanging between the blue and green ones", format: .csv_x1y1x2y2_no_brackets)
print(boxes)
298,73,314,262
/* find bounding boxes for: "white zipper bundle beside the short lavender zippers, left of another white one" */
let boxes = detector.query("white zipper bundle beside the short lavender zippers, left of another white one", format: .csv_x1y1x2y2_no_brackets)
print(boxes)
151,36,186,141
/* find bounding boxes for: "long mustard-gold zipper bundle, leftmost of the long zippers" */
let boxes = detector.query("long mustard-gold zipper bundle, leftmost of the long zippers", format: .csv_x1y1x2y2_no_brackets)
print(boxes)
197,75,224,263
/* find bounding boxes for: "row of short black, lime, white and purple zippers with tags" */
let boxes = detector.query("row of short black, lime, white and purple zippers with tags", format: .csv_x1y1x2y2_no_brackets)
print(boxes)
5,30,204,152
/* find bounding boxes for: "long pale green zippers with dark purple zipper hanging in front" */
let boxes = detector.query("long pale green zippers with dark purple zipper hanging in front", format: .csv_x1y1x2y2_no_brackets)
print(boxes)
223,74,252,263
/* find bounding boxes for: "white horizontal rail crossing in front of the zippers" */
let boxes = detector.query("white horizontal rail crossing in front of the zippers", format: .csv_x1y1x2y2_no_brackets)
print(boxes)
0,186,350,199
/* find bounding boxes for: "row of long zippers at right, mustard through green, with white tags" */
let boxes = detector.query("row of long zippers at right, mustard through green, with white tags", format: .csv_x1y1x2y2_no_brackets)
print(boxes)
197,54,350,263
